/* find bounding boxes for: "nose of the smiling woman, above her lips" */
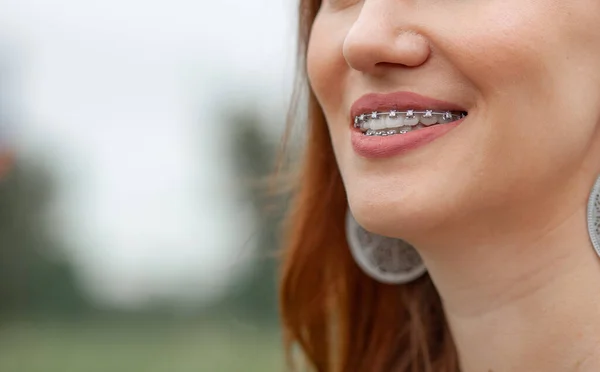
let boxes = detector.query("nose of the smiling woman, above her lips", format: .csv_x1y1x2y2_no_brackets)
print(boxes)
343,0,431,73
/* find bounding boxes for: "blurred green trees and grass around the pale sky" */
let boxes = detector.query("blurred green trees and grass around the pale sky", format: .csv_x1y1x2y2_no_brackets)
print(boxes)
0,106,285,372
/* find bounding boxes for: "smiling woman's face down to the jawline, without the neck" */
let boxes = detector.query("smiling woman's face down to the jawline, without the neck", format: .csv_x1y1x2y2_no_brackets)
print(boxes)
308,0,600,241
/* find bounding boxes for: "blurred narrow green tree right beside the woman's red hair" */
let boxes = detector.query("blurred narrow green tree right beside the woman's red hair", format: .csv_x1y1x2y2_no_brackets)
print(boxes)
213,109,285,324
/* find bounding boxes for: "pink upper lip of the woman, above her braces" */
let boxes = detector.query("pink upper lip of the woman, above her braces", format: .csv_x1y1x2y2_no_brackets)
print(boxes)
350,92,467,118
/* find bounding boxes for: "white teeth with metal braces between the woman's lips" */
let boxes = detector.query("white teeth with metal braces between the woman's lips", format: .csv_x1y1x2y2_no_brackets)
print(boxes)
354,110,467,136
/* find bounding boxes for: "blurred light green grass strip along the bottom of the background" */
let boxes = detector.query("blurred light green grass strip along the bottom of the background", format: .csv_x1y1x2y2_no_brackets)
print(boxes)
0,322,284,372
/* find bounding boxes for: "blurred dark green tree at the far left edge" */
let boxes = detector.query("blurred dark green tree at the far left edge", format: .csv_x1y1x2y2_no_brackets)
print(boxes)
0,154,88,318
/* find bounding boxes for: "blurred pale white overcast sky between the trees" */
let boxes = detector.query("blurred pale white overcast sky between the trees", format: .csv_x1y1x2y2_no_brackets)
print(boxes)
0,0,294,303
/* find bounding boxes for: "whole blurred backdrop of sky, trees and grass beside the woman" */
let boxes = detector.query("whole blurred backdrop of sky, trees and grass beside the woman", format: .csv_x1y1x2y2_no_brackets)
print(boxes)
0,0,296,372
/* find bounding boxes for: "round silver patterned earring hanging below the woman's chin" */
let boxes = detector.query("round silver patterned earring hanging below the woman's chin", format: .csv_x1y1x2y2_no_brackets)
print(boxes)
346,209,427,284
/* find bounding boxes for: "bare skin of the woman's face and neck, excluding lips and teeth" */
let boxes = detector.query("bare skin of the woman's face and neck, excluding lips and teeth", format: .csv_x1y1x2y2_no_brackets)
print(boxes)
307,0,600,372
